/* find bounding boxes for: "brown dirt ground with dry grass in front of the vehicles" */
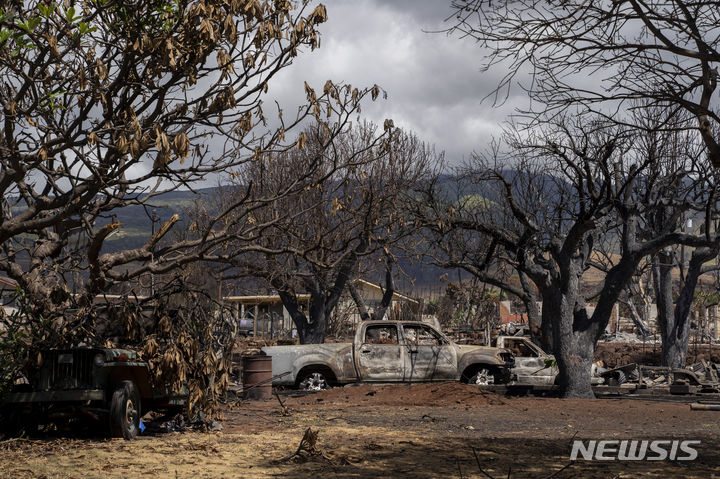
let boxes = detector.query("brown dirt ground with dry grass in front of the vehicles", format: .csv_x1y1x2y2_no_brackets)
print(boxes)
0,383,720,479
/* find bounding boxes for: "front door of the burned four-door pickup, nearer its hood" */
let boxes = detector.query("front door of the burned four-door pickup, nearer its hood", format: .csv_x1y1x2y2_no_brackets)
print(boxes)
402,324,457,381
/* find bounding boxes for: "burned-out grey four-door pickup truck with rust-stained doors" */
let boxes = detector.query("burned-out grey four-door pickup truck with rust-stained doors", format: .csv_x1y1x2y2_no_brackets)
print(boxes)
263,321,514,390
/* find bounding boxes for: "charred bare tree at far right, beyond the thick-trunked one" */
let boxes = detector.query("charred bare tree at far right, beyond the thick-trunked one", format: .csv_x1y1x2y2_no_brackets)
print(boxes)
595,108,720,367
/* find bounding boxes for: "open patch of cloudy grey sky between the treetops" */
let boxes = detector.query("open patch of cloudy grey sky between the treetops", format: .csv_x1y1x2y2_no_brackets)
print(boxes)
269,0,524,163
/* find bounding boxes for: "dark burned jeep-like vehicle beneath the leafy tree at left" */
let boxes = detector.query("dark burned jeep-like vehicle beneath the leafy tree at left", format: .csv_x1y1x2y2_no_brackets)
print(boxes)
0,348,185,439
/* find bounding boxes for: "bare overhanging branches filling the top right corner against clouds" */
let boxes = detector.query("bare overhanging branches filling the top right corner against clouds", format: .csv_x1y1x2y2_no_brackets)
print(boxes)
451,0,720,167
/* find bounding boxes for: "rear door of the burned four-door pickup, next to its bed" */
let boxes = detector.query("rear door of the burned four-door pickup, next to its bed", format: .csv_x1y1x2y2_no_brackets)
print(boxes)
357,324,405,382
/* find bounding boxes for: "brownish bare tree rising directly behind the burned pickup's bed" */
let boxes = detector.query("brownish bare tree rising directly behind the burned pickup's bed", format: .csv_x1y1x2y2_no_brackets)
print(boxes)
225,121,432,343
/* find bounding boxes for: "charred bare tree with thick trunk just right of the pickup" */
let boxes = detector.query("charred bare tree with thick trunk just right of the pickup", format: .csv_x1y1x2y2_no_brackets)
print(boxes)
417,112,711,397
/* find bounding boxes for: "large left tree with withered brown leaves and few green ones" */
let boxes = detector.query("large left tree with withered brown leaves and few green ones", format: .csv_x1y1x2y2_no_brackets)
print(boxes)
0,0,377,326
